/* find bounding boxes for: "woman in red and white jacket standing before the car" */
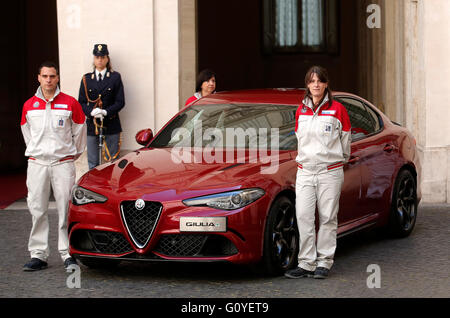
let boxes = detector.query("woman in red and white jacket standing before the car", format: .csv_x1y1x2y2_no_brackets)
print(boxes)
285,66,351,278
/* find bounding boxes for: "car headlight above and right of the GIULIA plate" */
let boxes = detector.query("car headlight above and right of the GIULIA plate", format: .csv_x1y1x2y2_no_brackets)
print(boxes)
183,188,265,210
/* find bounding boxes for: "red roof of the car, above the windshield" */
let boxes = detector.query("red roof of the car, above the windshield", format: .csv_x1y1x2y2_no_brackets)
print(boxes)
194,88,360,106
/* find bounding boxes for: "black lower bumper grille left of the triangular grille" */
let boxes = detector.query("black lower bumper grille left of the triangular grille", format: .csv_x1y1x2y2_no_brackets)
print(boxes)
70,230,133,255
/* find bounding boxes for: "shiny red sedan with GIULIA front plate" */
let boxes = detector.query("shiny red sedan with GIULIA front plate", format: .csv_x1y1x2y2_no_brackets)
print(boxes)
69,89,421,273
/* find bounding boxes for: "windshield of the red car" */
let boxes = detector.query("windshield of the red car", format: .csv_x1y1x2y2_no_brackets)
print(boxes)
150,104,297,150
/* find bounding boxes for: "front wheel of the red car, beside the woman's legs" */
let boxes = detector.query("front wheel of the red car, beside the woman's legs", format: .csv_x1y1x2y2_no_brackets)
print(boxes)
262,197,299,275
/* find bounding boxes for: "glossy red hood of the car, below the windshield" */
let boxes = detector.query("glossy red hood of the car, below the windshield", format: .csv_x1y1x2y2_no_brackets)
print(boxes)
79,148,291,197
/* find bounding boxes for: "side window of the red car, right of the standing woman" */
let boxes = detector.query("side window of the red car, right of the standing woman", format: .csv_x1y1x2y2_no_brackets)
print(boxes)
336,97,381,140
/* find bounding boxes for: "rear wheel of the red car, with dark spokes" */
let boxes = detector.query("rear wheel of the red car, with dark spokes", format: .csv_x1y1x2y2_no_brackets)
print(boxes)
388,170,417,237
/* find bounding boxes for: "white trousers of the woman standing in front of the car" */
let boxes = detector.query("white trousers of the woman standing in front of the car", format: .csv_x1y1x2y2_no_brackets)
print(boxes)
295,168,344,271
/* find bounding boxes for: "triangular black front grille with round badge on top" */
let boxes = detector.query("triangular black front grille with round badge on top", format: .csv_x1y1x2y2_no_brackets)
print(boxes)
120,201,162,248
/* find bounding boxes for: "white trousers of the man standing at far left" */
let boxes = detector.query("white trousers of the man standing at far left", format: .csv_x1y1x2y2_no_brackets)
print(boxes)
27,160,75,261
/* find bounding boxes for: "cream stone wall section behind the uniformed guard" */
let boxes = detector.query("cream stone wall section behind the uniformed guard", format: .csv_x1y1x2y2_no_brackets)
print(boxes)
57,0,197,177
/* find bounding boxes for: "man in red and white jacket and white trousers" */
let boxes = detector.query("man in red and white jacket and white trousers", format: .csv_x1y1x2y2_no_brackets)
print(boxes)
21,62,86,271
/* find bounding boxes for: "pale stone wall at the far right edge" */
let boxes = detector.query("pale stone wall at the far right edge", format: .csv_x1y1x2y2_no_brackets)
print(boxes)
418,0,450,203
